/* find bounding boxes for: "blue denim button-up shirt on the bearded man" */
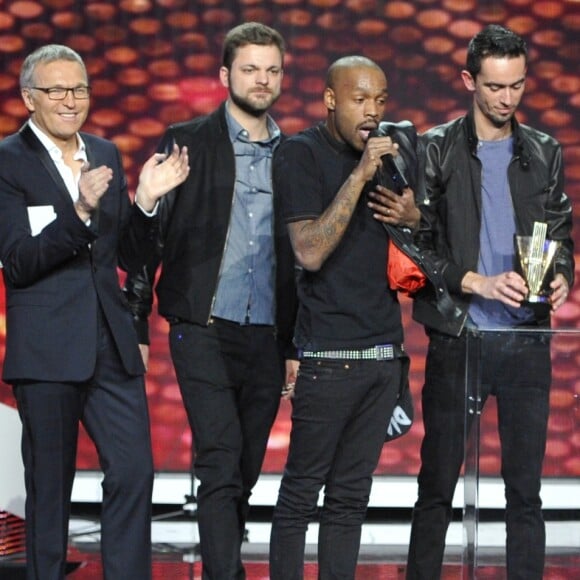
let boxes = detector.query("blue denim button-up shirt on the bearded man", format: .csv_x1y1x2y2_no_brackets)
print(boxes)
212,102,280,325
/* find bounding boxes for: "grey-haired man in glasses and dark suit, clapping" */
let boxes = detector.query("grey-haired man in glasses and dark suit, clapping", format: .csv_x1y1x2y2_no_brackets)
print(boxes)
0,45,189,580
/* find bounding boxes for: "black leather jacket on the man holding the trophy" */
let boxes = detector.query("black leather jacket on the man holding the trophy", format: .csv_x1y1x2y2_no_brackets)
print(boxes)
413,112,574,336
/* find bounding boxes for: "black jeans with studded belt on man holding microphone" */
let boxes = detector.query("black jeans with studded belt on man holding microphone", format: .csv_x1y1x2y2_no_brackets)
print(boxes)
270,359,402,580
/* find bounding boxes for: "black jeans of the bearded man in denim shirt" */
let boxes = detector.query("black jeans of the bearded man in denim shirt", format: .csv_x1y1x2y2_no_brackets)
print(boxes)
169,319,284,580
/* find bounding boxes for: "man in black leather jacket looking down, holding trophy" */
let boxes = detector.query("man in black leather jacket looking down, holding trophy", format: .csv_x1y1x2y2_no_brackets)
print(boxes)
407,25,574,580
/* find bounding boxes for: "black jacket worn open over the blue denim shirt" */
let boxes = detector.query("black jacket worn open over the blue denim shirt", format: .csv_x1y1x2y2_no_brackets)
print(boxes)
124,103,296,358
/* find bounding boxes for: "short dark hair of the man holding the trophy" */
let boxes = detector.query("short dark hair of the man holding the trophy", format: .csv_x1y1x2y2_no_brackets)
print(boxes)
465,24,528,79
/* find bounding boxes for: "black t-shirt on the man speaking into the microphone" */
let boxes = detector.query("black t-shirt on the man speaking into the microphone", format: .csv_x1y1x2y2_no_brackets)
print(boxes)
273,124,403,350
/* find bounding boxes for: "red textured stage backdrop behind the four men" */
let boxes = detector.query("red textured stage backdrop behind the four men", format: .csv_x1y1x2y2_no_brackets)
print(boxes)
0,0,580,477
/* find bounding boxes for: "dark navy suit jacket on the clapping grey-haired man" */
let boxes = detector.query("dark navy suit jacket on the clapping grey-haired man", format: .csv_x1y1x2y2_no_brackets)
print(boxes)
0,125,153,383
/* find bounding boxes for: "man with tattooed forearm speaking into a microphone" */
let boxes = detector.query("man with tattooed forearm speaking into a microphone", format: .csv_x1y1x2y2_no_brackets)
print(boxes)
270,56,419,580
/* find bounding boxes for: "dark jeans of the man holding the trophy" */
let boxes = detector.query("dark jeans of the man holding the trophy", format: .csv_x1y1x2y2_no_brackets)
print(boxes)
407,333,551,580
